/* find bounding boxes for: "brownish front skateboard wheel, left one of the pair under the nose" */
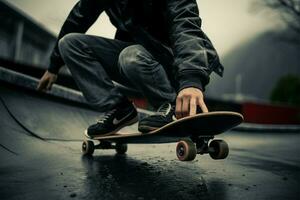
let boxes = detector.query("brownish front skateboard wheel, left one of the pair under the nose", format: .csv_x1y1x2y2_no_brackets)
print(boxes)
176,140,197,161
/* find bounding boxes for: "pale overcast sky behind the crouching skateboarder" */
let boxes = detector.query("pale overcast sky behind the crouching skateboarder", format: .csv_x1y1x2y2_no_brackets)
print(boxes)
7,0,279,56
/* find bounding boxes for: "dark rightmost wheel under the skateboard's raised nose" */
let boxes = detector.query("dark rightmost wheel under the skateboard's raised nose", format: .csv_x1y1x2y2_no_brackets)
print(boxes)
209,140,229,160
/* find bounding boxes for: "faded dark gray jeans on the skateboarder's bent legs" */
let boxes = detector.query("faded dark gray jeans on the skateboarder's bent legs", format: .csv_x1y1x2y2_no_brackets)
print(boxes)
58,33,176,112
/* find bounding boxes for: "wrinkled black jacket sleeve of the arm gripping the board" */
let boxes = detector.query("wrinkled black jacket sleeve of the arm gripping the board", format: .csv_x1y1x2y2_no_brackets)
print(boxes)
166,0,223,91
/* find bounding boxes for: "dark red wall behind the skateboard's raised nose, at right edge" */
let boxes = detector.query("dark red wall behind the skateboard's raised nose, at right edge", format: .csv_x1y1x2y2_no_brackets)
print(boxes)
242,103,300,124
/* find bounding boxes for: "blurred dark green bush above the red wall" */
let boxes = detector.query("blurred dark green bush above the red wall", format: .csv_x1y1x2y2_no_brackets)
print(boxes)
271,75,300,106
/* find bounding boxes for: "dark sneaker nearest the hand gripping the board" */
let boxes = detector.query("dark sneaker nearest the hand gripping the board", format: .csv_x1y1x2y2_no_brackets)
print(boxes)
138,103,176,133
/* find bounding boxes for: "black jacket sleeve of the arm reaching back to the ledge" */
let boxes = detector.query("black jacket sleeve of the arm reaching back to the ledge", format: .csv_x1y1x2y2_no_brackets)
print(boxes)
48,0,109,74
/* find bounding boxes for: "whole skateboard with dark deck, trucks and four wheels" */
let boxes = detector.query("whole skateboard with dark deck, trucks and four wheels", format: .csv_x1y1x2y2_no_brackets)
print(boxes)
82,111,243,161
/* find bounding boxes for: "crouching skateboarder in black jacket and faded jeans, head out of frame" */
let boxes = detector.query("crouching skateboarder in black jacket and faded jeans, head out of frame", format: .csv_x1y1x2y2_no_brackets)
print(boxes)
38,0,223,138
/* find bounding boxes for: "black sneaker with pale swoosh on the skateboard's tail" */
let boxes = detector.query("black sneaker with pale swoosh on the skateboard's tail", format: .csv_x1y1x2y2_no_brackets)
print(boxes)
85,100,138,138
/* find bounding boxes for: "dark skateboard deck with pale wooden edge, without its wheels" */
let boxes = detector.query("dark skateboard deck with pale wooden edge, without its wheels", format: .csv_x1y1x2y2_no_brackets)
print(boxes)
93,112,243,144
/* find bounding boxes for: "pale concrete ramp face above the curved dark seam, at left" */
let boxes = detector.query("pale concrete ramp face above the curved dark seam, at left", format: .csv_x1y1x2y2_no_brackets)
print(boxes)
0,84,137,141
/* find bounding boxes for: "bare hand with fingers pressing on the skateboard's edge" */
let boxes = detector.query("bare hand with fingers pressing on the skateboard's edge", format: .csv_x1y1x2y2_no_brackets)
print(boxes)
175,87,208,119
